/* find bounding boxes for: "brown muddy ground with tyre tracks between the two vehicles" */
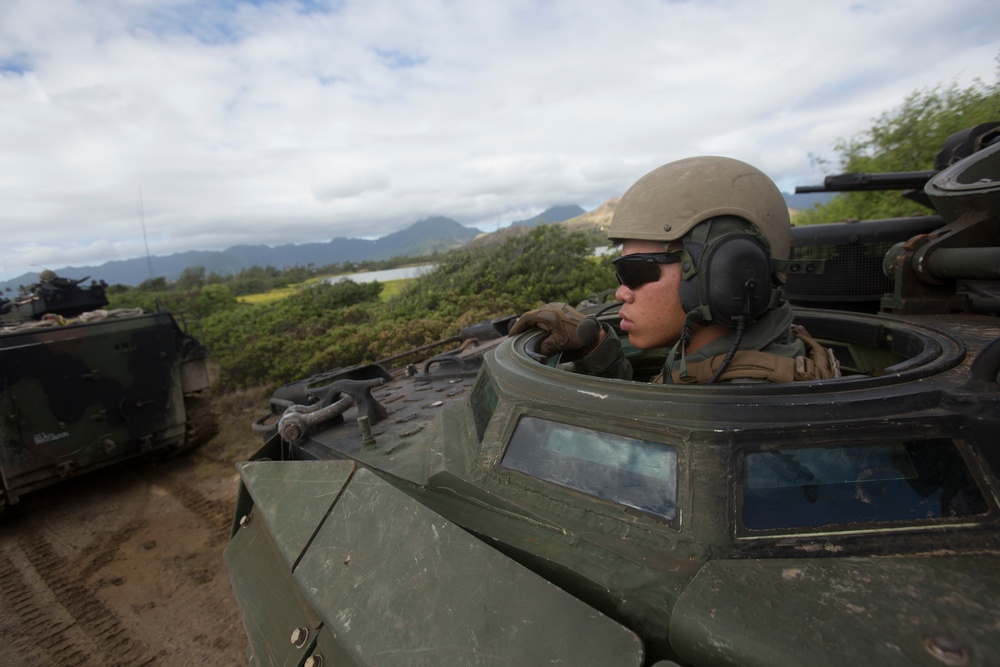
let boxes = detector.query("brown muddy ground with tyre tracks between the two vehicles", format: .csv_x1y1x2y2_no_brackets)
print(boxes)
0,392,267,666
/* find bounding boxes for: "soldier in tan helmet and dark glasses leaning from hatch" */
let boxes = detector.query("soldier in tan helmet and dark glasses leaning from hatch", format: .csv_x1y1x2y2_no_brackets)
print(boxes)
511,157,840,383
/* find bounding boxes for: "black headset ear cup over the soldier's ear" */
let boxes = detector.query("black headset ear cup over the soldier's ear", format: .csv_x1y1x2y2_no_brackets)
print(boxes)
698,234,773,327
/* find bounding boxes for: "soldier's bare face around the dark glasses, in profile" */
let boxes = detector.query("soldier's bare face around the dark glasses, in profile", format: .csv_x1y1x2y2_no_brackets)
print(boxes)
615,240,684,350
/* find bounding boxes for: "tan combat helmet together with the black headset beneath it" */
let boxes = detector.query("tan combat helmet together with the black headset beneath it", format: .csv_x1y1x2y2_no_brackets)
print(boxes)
608,156,791,328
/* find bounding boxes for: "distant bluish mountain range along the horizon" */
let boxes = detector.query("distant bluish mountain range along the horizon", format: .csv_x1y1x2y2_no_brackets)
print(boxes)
0,193,832,294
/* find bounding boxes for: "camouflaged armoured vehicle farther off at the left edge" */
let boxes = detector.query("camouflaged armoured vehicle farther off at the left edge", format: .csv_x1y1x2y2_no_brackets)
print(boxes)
0,270,218,513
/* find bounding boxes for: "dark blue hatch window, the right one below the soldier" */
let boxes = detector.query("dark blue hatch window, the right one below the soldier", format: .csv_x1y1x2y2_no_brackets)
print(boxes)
743,439,987,530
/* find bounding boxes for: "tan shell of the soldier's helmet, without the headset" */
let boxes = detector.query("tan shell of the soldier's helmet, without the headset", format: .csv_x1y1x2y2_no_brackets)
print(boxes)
608,156,791,260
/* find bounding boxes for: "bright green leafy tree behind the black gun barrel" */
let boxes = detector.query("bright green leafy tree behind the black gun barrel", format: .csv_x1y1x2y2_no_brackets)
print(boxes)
795,65,1000,225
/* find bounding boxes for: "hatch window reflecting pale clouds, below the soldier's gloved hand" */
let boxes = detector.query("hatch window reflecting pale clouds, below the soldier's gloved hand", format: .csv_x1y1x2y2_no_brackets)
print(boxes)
501,417,677,520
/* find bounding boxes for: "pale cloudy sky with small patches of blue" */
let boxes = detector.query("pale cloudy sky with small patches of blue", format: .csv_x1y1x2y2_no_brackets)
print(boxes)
0,0,1000,279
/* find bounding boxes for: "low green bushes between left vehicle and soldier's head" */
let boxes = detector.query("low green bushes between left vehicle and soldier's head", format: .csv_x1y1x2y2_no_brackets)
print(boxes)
109,225,615,391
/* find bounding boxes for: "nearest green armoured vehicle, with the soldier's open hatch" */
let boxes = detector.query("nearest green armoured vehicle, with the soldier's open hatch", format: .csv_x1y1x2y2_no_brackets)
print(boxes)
225,124,1000,667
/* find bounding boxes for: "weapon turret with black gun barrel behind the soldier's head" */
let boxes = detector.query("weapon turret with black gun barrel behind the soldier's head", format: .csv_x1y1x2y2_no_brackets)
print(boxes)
786,122,1000,313
